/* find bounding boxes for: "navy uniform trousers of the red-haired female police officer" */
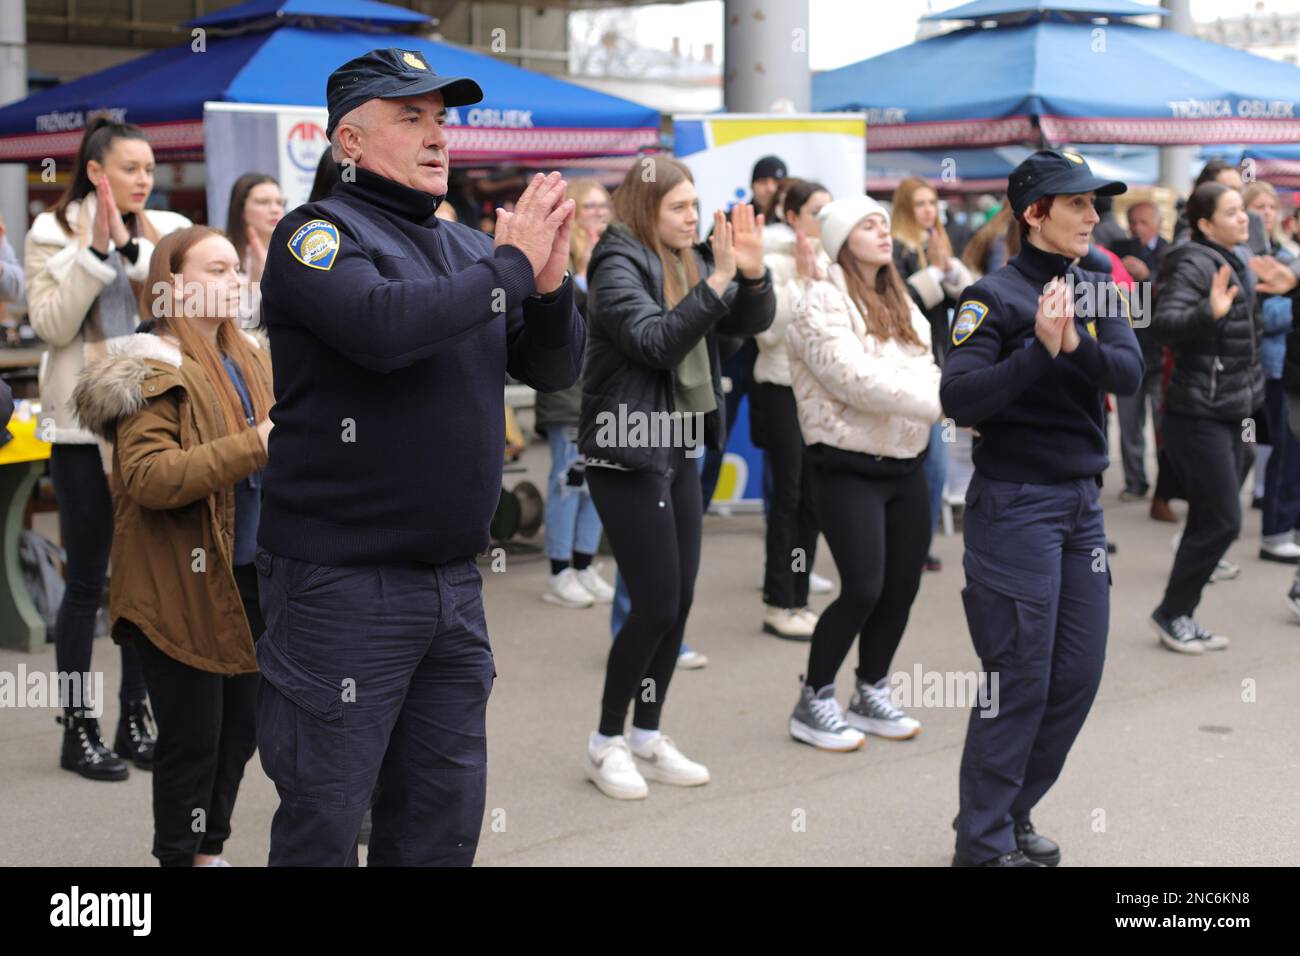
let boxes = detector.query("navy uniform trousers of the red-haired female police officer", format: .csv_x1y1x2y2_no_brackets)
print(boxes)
957,472,1110,862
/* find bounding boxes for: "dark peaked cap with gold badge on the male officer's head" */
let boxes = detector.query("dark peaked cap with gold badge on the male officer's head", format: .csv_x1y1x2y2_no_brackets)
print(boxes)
325,47,484,135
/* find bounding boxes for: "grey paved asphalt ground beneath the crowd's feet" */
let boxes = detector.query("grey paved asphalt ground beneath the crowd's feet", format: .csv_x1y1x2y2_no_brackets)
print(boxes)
0,418,1300,866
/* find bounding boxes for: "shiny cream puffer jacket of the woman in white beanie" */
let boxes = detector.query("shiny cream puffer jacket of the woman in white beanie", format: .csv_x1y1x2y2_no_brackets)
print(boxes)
785,265,943,458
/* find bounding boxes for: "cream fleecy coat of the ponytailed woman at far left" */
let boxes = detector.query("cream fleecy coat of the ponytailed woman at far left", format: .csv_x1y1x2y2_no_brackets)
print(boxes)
23,200,190,445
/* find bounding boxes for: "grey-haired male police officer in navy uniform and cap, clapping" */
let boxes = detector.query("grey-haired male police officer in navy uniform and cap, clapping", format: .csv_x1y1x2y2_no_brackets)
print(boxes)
257,49,585,866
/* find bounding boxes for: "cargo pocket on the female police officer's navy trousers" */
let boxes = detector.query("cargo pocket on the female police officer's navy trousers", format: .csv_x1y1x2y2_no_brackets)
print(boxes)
962,548,1052,665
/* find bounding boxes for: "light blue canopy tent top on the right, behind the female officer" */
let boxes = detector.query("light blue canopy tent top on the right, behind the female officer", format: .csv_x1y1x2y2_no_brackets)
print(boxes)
813,0,1300,150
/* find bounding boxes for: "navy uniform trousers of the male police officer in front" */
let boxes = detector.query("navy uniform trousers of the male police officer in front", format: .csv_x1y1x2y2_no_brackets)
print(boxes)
256,549,497,866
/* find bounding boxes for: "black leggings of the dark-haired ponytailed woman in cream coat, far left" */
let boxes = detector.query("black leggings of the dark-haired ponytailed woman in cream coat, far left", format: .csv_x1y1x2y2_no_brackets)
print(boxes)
49,445,146,704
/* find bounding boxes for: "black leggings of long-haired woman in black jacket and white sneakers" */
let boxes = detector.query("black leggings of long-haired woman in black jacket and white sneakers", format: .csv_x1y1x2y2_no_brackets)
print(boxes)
586,449,703,737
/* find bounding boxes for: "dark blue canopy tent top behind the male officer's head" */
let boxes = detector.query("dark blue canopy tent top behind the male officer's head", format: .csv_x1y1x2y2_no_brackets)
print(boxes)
0,0,659,163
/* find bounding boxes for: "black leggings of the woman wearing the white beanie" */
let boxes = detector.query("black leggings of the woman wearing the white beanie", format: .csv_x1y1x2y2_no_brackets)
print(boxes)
806,466,930,689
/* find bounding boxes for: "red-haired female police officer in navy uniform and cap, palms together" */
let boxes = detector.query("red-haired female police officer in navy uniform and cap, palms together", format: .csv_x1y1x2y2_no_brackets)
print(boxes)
940,150,1143,866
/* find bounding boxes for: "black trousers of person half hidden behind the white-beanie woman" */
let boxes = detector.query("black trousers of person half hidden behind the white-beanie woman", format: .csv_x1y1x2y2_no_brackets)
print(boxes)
751,382,818,607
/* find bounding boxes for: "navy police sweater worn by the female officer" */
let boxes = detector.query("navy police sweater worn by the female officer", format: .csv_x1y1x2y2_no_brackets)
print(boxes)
939,242,1143,484
